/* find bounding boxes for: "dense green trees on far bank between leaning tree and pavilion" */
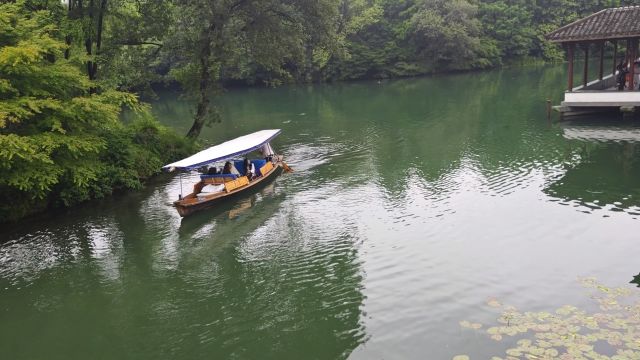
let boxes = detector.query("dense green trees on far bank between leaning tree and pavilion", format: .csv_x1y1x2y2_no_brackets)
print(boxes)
322,0,640,80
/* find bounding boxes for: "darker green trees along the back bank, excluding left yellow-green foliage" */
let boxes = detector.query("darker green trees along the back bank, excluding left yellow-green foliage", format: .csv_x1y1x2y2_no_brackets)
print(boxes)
63,0,640,138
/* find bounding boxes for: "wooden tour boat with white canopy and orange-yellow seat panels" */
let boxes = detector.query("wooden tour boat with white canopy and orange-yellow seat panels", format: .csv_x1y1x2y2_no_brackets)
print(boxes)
163,129,290,217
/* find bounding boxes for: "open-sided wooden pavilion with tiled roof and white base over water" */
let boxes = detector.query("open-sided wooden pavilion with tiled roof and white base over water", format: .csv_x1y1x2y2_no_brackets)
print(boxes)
546,6,640,115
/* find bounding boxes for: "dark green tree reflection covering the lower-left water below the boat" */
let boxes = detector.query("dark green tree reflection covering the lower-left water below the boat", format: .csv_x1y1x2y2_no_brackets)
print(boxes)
0,171,366,359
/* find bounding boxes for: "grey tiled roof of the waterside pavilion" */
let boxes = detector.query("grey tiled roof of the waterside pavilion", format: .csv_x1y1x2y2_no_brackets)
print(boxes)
546,6,640,42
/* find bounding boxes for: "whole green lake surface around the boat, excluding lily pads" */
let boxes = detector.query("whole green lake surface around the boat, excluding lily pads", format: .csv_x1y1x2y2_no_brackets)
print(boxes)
0,67,640,359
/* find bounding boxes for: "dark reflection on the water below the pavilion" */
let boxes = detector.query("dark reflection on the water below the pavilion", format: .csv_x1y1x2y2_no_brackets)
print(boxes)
544,120,640,216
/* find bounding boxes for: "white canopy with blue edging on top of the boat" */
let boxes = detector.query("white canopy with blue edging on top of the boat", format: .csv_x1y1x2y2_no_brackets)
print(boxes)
162,129,281,171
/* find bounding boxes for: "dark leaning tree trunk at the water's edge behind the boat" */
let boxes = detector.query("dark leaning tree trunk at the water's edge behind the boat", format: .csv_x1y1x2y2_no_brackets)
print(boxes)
187,25,214,139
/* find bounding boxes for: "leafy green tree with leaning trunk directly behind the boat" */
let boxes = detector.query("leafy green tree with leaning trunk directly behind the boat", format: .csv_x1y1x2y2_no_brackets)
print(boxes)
167,0,338,138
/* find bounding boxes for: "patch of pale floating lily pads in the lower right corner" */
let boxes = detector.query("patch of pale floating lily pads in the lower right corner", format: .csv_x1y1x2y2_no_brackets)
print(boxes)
454,278,640,360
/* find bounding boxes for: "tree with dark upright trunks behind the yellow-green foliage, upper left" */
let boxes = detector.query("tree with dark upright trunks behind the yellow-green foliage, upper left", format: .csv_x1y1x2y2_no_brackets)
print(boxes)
55,0,172,91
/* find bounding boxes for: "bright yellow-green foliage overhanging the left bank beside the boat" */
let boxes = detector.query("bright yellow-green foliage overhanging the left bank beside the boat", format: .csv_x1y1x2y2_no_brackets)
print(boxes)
0,1,192,222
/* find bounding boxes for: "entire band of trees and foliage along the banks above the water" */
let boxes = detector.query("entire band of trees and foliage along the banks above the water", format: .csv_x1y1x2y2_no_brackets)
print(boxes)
0,0,638,222
